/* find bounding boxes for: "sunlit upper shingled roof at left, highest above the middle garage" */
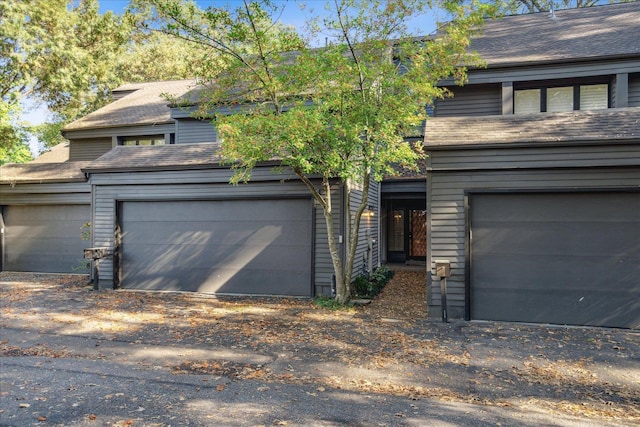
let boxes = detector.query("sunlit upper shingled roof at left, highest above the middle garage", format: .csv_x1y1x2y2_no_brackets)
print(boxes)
62,80,196,132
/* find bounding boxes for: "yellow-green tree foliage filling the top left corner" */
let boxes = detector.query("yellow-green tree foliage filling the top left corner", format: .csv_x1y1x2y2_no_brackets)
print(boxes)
0,0,131,119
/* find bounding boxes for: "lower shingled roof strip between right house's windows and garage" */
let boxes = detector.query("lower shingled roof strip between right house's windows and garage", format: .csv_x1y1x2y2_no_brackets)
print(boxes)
424,107,640,149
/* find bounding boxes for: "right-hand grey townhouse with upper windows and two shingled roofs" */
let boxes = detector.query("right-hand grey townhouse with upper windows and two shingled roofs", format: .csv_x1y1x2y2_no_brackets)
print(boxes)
425,2,640,328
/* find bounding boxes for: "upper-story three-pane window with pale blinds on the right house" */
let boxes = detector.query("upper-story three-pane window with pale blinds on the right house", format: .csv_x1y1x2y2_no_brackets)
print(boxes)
513,83,609,114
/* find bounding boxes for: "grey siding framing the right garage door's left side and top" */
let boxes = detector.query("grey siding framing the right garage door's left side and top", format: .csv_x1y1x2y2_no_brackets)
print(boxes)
428,166,640,317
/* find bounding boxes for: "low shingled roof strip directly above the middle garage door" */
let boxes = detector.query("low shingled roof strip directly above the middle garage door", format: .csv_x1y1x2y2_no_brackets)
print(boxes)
83,144,222,172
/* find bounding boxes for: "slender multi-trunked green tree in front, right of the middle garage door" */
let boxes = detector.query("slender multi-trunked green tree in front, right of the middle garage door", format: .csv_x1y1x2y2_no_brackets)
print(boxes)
150,0,493,303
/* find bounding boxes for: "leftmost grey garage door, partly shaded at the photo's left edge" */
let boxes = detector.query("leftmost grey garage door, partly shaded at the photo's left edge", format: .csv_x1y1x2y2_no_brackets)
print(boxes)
2,205,91,273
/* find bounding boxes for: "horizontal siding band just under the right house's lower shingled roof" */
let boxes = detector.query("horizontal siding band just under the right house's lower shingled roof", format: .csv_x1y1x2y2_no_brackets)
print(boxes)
430,142,640,170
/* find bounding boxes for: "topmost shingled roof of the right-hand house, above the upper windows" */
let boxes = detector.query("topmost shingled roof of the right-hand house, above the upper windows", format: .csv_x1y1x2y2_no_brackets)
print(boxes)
471,1,640,68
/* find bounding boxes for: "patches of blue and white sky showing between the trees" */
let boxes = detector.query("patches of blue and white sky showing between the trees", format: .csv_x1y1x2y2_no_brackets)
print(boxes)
26,0,445,155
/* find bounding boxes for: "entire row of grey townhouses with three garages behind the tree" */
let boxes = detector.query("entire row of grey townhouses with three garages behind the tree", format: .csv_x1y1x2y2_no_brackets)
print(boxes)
0,2,640,328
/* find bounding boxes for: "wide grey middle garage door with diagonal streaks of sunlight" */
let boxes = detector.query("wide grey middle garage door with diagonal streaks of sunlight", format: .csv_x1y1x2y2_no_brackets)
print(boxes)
120,199,312,296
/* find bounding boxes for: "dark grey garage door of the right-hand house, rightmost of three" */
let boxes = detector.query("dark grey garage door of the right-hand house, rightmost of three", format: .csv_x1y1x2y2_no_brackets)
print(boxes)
470,193,640,328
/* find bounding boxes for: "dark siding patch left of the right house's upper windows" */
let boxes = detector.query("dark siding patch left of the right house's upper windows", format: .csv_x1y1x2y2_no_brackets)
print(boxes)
434,84,502,117
